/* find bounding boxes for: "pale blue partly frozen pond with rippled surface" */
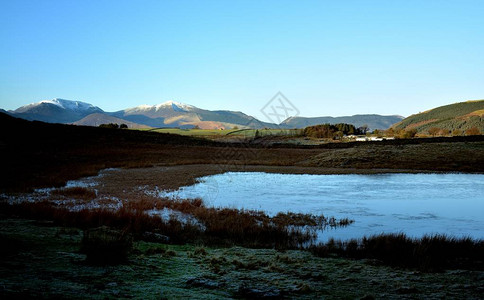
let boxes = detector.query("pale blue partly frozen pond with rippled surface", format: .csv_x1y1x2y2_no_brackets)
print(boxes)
164,172,484,241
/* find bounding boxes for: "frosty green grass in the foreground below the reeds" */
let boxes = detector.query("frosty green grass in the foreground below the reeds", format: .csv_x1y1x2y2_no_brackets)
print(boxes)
0,217,484,299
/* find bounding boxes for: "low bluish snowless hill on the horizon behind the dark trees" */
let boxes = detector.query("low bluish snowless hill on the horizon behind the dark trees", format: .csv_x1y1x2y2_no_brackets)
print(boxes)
281,115,403,130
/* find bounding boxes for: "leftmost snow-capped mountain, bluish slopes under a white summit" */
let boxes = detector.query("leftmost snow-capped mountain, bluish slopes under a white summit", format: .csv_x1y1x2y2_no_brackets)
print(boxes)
9,98,103,123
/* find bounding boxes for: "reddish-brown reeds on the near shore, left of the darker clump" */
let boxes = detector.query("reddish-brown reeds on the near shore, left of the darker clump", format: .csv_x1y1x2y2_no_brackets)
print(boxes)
1,197,350,249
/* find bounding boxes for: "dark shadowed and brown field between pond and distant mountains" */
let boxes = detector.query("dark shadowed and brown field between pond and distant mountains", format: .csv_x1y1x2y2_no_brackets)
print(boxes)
0,114,484,192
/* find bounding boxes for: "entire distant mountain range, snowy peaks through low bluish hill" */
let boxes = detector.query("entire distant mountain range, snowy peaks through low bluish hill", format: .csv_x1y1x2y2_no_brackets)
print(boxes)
8,98,402,129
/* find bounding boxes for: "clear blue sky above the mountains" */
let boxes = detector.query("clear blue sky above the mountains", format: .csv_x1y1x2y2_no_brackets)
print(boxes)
0,0,484,118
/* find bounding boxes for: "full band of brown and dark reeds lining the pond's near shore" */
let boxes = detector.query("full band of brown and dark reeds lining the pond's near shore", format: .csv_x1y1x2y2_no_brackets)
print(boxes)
0,200,484,271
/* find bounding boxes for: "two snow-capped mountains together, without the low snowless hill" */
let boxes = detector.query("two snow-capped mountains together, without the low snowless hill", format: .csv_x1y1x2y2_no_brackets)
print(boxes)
8,98,275,129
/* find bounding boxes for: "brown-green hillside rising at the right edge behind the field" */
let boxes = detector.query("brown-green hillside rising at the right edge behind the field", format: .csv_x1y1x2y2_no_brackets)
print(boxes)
392,100,484,134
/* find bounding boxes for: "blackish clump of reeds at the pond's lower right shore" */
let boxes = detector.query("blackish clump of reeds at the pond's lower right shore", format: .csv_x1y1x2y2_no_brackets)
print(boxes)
310,233,484,271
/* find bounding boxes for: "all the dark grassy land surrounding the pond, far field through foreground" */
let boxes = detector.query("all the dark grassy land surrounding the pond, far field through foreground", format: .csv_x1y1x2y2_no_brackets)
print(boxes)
0,115,484,299
